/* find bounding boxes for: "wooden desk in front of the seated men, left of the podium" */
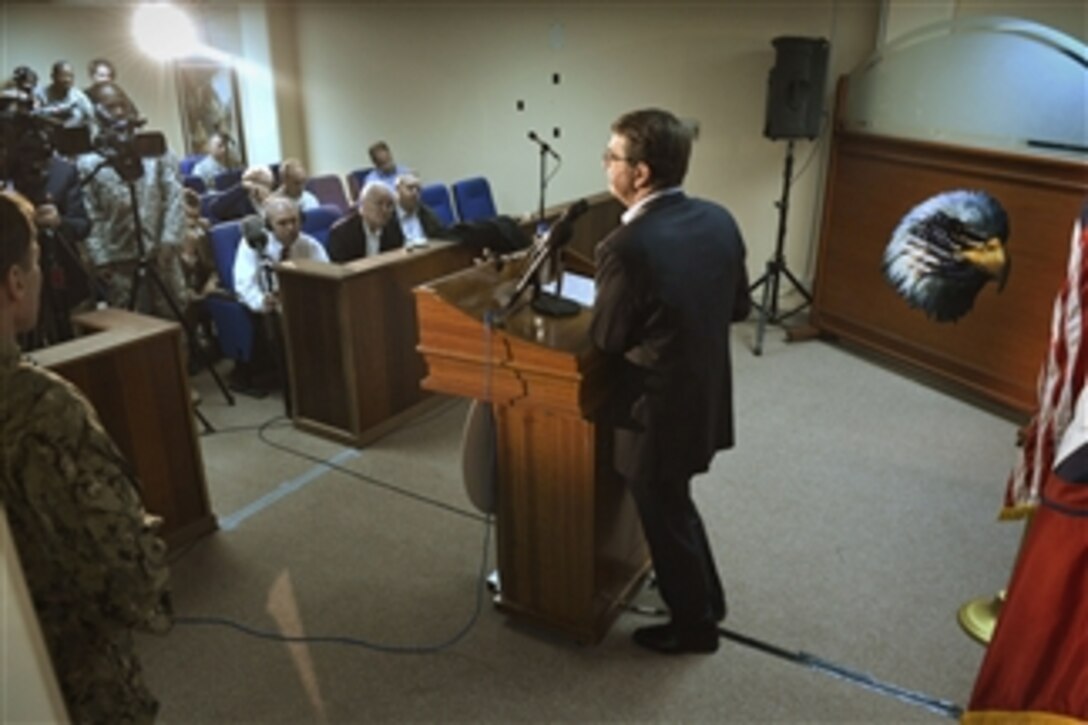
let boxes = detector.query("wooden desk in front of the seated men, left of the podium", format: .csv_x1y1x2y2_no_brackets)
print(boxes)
276,242,473,446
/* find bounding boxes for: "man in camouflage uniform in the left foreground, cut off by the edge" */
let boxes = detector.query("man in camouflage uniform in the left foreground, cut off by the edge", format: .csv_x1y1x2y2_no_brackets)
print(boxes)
0,187,171,723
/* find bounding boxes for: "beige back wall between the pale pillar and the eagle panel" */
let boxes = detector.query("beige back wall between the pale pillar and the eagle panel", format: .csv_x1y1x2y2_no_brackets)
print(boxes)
298,0,878,273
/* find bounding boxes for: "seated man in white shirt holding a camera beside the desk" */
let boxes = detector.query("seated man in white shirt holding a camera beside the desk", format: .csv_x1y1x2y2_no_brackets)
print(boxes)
231,196,329,389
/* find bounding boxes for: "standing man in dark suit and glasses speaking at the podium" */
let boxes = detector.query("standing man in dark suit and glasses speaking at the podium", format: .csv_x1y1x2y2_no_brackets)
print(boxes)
591,109,751,653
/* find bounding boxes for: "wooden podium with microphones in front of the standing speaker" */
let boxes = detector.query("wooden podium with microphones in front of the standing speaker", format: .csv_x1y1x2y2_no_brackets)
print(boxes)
416,260,650,643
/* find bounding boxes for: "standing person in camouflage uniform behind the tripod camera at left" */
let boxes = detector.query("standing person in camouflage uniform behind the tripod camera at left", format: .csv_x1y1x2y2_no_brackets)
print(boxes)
76,83,188,319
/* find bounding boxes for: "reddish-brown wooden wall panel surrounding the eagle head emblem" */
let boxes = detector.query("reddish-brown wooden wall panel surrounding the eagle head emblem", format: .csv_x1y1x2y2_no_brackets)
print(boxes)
812,131,1088,414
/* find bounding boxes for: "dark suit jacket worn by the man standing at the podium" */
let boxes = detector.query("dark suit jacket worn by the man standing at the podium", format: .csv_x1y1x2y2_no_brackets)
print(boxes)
590,194,751,478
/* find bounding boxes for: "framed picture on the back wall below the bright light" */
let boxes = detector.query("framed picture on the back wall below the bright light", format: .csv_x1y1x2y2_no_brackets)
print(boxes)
176,61,246,165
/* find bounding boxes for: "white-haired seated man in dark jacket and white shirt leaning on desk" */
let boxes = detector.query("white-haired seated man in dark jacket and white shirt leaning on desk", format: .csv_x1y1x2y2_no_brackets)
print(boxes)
329,182,405,262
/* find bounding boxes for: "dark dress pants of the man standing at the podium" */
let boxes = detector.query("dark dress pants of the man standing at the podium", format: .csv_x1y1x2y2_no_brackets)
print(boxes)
628,474,726,628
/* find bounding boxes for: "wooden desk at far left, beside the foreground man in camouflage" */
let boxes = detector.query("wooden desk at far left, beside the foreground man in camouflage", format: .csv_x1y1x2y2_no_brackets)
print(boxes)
32,309,217,548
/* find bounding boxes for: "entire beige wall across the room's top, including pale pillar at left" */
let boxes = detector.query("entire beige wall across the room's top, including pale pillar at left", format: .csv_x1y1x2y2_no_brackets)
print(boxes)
0,0,1086,274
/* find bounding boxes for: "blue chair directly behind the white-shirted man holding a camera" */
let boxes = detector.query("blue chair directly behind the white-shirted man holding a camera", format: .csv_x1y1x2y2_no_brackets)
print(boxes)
205,221,254,363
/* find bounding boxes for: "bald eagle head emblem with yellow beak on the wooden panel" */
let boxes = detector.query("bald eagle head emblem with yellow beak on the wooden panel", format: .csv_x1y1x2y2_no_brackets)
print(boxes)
883,191,1010,322
